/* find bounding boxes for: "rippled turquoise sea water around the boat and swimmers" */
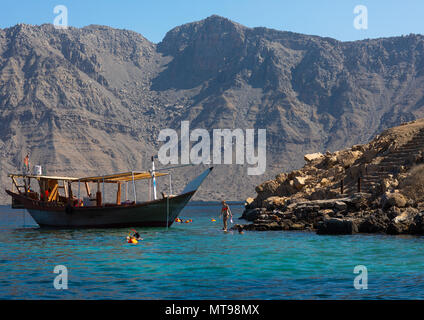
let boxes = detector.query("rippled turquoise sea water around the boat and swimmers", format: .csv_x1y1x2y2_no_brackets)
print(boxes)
0,204,424,299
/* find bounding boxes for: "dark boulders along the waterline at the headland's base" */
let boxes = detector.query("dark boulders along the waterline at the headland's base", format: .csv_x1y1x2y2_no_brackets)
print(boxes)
234,193,424,235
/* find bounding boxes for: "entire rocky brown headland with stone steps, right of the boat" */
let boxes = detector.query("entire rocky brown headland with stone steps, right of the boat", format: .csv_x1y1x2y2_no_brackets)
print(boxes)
234,120,424,235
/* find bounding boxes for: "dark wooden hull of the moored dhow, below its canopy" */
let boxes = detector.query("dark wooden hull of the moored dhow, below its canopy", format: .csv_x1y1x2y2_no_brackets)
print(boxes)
6,190,195,228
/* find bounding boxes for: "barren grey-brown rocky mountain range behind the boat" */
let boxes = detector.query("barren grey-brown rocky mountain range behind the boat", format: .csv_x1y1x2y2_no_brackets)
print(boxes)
0,16,424,201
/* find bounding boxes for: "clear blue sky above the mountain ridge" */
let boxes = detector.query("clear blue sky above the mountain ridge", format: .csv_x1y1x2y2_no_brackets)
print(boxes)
0,0,424,42
